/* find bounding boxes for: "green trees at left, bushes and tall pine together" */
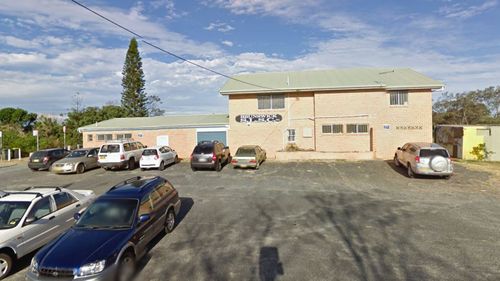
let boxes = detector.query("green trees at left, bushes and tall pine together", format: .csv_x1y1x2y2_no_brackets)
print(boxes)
0,38,164,154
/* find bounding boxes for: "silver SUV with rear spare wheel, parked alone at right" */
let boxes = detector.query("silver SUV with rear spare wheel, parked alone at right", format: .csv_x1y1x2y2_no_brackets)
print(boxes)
394,142,453,178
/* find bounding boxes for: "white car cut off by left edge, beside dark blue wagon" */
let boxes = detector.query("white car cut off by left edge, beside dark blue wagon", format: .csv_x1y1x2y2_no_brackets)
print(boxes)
0,187,95,279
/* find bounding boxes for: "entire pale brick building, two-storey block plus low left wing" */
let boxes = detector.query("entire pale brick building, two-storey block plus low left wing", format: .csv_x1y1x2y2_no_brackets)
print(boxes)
79,68,443,159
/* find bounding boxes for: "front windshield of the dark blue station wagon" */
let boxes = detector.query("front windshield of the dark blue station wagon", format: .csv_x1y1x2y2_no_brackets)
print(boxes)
75,199,139,229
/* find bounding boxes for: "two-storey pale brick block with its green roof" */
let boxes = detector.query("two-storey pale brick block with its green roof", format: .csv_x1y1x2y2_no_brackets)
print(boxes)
220,69,443,159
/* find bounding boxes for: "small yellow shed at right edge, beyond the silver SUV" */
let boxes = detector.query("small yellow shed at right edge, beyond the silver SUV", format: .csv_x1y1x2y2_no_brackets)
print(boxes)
436,125,500,161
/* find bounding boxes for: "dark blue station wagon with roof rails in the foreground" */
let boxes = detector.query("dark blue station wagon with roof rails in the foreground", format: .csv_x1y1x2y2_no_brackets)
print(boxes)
26,177,181,281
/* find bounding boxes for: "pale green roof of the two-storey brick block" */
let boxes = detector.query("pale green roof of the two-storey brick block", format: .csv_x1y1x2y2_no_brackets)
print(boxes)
220,68,444,95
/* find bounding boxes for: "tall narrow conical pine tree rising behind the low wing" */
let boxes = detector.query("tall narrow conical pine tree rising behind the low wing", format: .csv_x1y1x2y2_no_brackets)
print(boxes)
122,38,148,117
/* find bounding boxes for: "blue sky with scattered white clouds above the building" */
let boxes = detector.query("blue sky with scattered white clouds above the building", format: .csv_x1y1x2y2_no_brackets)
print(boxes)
0,0,500,115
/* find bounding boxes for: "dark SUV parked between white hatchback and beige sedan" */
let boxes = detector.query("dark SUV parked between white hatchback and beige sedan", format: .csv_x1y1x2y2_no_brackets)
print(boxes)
191,141,231,172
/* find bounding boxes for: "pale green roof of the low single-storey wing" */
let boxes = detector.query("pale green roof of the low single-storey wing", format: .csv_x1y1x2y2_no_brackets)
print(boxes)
78,114,229,132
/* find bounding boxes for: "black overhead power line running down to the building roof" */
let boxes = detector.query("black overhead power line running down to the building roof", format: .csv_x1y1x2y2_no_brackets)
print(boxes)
71,0,278,90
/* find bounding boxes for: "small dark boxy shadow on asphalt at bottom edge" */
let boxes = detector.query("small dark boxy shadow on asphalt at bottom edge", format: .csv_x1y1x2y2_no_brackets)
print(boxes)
259,247,285,281
